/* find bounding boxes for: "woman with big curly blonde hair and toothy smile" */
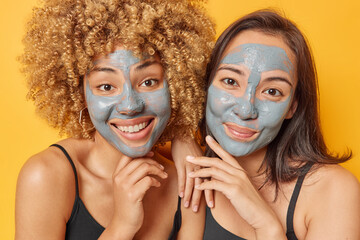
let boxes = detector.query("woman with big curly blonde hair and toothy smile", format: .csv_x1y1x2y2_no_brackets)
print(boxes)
16,0,214,240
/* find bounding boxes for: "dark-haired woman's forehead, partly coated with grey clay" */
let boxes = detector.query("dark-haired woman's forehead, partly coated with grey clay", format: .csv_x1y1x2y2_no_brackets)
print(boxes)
221,30,296,71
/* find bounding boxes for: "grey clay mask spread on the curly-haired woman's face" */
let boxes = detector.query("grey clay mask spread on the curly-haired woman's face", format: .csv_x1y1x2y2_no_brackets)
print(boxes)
85,50,171,157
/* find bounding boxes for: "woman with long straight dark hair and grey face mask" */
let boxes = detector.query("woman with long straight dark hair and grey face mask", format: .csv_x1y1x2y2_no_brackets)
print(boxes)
187,10,360,240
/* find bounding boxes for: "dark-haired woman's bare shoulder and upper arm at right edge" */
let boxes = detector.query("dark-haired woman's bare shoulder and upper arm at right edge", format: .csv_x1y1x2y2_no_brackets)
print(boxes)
304,165,360,239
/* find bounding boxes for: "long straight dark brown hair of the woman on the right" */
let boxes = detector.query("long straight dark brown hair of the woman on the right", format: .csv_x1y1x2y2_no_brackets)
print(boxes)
201,10,352,189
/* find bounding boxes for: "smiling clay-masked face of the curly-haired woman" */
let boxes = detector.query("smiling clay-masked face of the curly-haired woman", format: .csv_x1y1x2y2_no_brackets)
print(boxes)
84,48,171,157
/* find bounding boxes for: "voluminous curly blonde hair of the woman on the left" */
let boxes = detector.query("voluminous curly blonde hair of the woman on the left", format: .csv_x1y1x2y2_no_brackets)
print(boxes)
20,0,215,142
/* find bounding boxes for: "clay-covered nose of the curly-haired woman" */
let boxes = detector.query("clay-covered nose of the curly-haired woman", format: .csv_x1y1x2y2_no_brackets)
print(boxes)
116,91,145,115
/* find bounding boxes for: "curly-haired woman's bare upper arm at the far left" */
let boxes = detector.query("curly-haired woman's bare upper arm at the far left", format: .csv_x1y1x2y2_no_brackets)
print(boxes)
15,150,75,240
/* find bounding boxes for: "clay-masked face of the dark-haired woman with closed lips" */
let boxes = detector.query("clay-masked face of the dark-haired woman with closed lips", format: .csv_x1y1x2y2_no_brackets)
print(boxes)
206,30,297,157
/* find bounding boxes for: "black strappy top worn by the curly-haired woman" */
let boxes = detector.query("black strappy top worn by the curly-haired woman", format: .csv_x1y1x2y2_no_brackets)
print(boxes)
51,144,181,240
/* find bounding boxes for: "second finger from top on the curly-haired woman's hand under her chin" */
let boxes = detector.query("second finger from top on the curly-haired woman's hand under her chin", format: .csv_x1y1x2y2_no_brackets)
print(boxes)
126,162,168,185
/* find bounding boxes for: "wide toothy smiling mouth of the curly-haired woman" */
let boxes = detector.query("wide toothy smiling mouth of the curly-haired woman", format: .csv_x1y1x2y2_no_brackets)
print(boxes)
109,117,155,145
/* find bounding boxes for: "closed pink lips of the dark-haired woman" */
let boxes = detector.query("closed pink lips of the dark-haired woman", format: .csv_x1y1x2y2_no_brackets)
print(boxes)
223,122,260,142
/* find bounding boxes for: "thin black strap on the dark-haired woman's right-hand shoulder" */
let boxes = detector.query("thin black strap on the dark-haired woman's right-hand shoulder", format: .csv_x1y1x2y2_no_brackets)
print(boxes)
286,163,313,232
